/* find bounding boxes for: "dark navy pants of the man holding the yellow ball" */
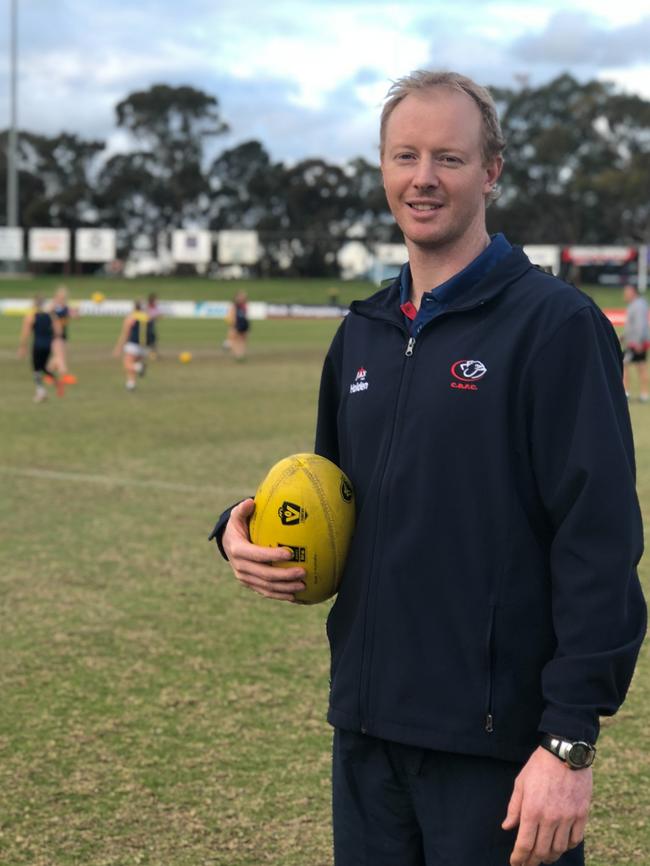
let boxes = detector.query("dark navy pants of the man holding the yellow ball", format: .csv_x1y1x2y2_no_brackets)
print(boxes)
332,729,584,866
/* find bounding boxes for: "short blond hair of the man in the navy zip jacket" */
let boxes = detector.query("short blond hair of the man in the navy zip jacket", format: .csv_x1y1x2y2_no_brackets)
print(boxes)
379,69,506,200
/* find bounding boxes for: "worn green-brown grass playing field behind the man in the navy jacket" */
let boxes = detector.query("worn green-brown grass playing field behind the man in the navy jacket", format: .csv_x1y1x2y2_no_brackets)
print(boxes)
0,294,650,866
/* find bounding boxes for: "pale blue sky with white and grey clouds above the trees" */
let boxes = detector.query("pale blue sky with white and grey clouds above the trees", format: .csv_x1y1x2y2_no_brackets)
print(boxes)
0,0,650,161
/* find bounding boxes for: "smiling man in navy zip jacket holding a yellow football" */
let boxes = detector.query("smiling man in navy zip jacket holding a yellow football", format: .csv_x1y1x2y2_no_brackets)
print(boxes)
215,72,646,866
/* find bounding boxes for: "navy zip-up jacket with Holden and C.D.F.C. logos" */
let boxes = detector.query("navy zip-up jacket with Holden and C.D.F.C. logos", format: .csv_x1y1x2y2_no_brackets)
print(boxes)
316,248,646,760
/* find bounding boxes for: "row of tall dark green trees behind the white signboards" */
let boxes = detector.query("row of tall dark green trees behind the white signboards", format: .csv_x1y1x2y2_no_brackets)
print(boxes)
0,74,650,275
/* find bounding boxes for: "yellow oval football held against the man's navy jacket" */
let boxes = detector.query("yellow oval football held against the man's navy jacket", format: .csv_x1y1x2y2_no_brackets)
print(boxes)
250,454,355,604
